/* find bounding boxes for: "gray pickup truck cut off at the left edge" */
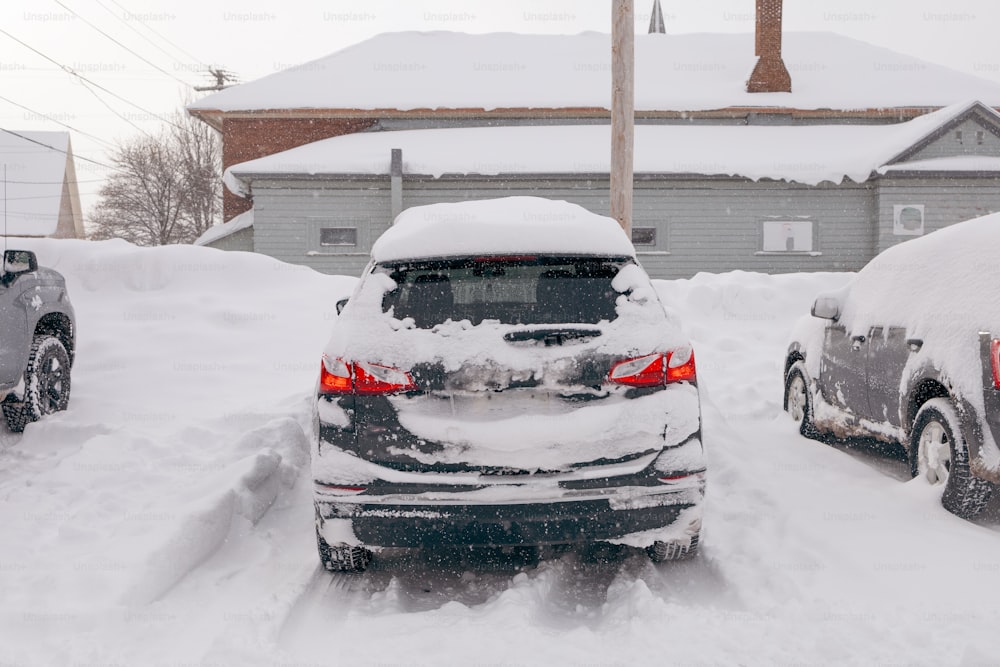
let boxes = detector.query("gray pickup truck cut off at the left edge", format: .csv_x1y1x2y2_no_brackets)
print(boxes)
0,250,76,433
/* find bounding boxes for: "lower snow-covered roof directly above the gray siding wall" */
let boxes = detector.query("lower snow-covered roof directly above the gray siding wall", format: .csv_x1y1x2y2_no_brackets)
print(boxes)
224,102,1000,196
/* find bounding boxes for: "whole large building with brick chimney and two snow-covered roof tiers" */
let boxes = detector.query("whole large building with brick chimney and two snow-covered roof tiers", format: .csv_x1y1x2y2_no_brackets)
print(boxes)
189,0,1000,277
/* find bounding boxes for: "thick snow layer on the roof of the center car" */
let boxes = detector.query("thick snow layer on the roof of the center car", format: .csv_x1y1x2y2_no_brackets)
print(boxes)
372,197,635,262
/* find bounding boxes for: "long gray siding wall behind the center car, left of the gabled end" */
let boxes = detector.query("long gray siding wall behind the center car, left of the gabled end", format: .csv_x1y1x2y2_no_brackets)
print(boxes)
254,176,876,278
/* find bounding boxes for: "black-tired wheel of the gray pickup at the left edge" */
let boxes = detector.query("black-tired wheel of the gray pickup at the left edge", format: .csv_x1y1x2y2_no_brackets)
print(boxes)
3,335,71,433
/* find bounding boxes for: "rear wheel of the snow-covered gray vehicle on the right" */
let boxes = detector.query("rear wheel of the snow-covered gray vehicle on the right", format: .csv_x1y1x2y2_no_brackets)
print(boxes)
910,398,993,519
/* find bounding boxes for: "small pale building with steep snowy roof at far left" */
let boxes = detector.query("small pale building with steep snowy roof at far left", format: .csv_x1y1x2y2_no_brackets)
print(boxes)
0,130,86,238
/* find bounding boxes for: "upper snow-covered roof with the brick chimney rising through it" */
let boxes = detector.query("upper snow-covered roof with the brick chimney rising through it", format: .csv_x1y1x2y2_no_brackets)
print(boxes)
188,32,1000,111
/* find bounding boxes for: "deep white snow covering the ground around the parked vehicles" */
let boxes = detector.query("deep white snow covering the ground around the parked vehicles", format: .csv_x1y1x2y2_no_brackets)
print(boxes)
0,240,1000,667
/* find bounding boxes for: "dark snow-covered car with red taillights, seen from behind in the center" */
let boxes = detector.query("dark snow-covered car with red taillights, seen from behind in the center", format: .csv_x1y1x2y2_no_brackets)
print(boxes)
312,197,706,571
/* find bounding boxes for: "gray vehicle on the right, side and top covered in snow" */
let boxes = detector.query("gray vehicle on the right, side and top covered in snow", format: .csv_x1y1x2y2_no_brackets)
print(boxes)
784,214,1000,517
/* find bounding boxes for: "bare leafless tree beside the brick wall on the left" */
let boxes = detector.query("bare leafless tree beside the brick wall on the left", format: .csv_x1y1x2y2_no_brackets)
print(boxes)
90,112,222,246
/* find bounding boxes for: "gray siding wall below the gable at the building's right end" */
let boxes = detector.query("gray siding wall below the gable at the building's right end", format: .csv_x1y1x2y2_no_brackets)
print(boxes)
878,175,1000,252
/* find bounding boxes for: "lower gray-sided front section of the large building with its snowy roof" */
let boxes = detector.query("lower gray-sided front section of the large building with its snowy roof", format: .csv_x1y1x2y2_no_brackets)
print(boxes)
208,102,1000,278
